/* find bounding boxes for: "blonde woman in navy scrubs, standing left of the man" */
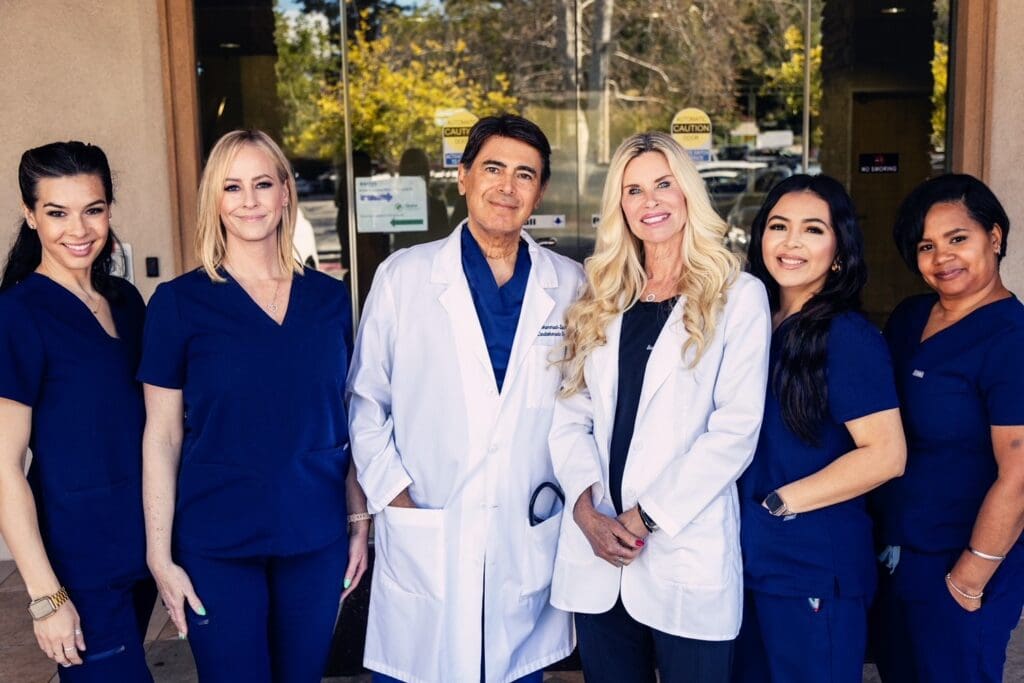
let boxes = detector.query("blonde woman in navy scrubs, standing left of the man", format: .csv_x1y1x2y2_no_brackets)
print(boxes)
139,131,369,683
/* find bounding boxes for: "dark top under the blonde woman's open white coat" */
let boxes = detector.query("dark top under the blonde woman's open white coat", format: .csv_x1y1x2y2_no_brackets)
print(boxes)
608,297,677,514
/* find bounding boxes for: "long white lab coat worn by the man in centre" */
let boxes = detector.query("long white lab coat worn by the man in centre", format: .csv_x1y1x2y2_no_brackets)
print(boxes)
348,223,583,683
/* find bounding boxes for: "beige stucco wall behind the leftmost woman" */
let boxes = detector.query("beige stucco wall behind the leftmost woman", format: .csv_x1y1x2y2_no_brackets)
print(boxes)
0,0,174,559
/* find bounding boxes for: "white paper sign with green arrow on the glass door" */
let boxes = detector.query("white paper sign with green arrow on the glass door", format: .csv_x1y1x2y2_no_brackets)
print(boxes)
355,175,427,232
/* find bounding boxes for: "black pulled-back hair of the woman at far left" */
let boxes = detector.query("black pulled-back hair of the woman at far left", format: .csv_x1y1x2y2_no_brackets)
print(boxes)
0,140,123,299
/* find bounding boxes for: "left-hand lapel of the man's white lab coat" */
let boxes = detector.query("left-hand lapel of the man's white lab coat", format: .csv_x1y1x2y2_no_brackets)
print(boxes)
430,222,497,387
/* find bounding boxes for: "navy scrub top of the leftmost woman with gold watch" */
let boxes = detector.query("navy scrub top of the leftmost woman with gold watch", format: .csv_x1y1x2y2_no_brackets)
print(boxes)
0,273,147,588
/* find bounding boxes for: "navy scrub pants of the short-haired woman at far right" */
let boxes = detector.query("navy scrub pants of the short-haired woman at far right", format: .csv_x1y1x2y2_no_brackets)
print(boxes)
871,548,1024,683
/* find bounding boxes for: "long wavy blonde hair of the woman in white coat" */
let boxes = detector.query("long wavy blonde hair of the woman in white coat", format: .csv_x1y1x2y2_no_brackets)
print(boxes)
560,132,739,397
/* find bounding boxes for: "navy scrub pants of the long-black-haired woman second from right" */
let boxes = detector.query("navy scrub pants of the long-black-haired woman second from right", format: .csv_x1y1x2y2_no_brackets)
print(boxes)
732,591,867,683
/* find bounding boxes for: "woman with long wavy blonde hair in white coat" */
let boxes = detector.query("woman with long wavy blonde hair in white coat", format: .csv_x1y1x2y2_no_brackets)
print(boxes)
550,133,771,683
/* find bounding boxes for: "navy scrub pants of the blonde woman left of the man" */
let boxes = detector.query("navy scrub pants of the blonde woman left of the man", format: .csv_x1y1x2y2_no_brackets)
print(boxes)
177,537,348,683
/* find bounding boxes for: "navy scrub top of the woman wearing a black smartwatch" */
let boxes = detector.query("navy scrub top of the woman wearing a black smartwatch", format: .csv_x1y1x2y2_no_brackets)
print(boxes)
737,312,898,597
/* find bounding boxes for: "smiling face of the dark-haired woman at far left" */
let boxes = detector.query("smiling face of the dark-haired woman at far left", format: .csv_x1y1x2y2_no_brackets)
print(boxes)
24,175,111,273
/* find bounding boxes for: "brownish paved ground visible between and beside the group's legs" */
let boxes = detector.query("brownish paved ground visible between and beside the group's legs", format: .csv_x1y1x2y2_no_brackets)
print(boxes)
0,561,1024,683
